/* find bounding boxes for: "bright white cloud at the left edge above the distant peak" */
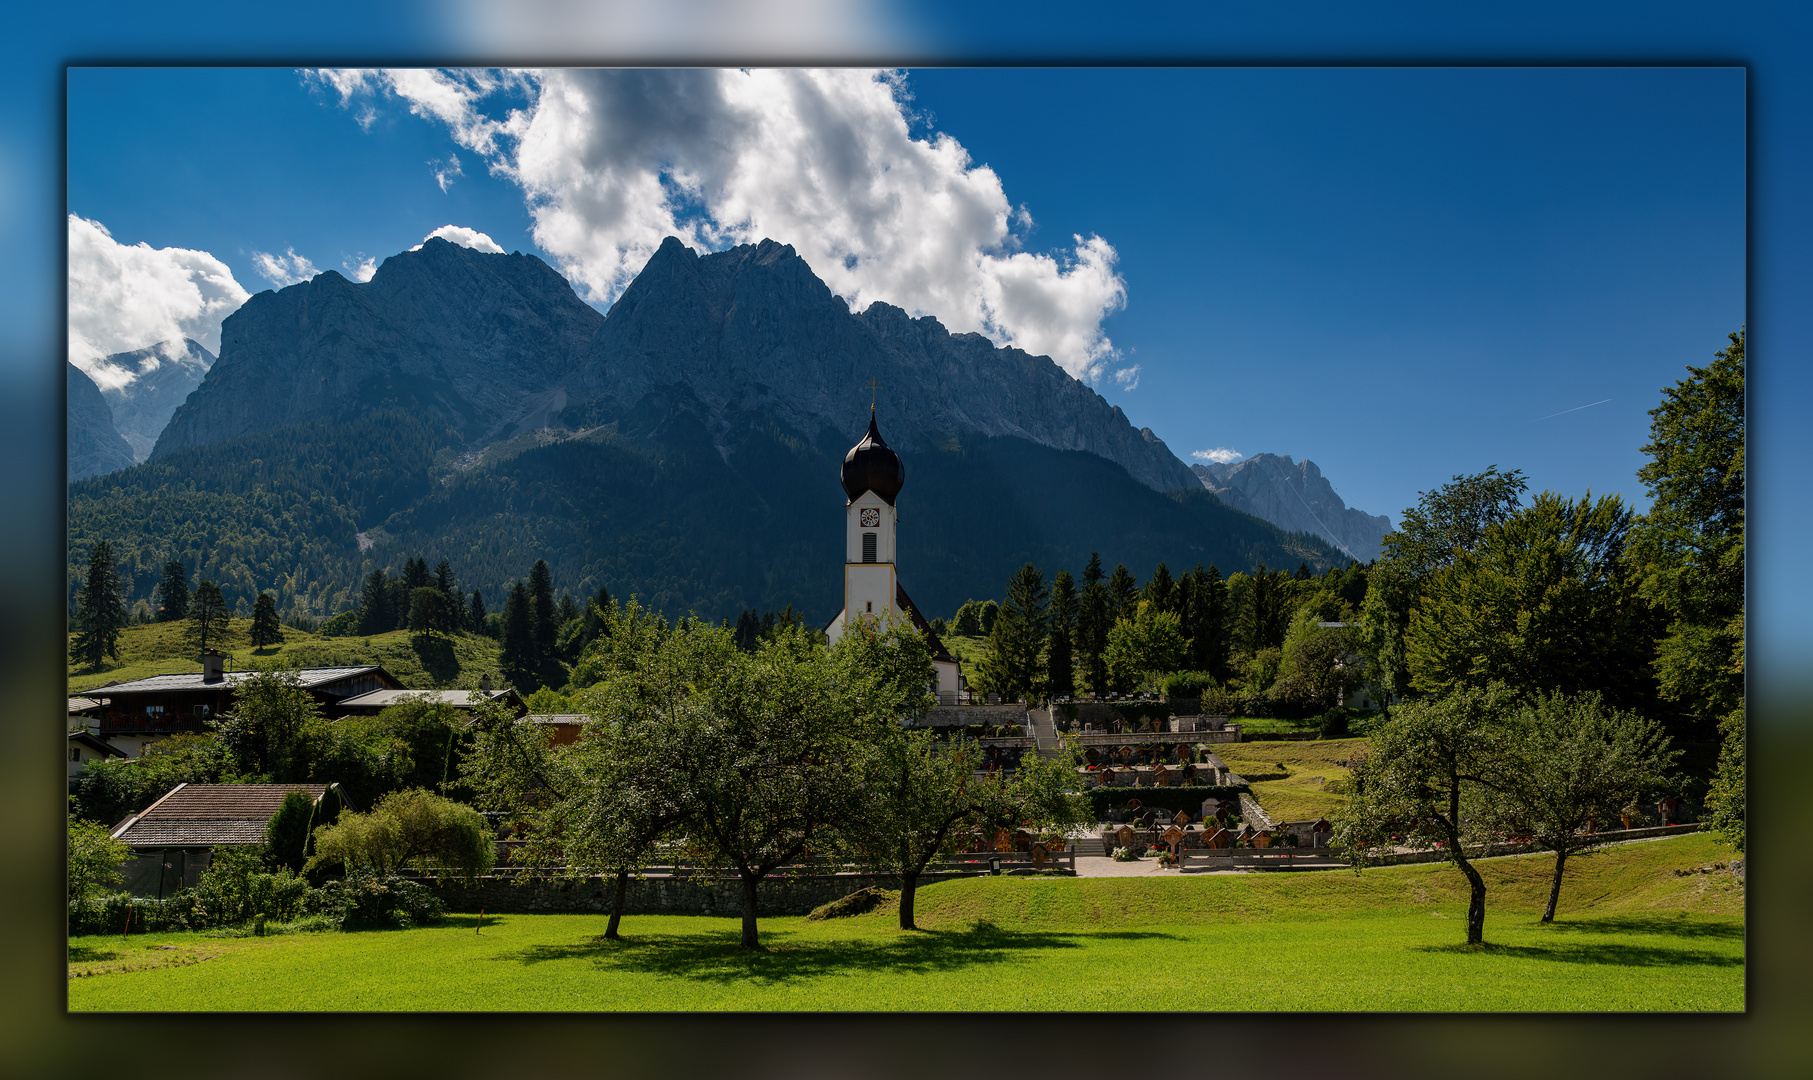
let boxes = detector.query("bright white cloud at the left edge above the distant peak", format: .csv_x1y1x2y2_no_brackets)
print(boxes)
69,214,250,390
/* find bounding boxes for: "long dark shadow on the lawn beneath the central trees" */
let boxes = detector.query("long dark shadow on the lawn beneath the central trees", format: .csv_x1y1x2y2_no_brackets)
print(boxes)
499,924,1180,984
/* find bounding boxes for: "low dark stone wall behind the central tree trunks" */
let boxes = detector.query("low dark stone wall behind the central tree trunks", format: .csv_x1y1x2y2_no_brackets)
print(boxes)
422,873,975,915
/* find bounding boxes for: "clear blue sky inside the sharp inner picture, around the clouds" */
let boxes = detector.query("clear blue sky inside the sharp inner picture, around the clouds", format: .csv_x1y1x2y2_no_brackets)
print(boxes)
69,67,1746,532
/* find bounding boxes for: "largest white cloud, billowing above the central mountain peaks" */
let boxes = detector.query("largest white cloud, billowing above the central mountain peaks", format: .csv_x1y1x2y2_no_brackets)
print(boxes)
308,69,1139,388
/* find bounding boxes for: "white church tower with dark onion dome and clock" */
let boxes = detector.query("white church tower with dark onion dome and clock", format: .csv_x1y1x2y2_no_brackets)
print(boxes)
830,410,907,641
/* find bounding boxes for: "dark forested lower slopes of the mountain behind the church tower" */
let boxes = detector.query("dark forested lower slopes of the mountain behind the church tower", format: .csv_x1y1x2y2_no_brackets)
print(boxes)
69,402,1345,622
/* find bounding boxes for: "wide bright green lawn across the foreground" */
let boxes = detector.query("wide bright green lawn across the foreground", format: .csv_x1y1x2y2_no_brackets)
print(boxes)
69,835,1744,1011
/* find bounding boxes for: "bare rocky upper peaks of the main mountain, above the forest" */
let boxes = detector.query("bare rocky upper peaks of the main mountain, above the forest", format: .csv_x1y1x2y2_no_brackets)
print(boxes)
154,237,1195,491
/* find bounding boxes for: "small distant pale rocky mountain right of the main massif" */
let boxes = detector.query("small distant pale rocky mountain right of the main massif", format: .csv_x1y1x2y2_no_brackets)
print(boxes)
1191,453,1391,562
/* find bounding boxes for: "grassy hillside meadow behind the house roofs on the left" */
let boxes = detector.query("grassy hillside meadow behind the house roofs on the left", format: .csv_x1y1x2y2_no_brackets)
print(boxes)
69,618,500,694
